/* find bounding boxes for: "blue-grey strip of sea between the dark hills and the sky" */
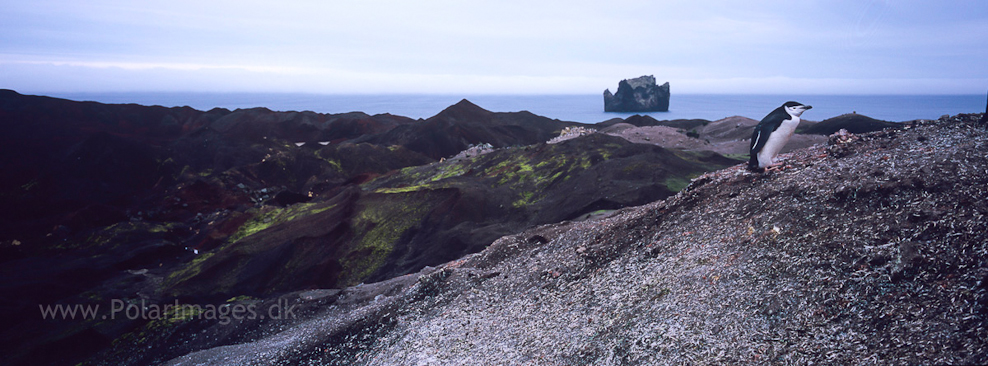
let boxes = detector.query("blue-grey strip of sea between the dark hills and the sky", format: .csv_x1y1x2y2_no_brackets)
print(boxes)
48,92,986,123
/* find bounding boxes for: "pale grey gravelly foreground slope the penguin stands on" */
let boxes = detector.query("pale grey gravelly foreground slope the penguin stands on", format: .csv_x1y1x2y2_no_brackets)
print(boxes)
119,115,988,365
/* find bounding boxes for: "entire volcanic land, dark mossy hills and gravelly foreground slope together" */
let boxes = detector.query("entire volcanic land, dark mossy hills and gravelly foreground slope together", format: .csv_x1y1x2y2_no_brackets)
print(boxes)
0,91,972,365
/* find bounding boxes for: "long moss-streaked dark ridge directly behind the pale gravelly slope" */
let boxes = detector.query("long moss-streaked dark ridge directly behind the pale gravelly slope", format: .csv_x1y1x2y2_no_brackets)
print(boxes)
167,136,734,300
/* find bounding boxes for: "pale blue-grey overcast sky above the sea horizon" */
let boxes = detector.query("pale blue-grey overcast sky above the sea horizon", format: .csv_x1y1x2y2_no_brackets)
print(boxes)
0,0,988,94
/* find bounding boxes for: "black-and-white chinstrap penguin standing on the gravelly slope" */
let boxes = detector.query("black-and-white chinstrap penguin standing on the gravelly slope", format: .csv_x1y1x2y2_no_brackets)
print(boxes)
748,101,813,172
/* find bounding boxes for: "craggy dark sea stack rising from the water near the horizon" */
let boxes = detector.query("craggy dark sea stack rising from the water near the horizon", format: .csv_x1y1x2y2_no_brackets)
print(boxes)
604,75,669,112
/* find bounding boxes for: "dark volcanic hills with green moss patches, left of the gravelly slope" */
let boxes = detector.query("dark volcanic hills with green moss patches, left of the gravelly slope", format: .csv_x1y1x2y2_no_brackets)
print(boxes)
0,91,734,365
